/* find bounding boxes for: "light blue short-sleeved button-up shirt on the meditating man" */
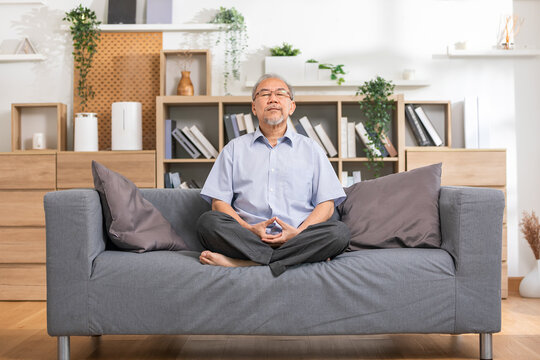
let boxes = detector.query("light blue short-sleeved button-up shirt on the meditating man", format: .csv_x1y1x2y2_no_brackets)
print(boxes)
201,128,346,227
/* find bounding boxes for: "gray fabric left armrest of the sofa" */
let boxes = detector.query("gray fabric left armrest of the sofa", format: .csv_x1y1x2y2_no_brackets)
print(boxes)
44,190,105,336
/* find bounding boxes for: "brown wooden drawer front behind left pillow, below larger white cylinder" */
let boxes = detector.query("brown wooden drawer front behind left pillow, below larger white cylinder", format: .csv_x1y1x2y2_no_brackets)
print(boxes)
56,151,156,189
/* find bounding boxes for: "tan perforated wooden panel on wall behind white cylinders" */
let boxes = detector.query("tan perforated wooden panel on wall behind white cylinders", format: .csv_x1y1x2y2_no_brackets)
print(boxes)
73,32,163,150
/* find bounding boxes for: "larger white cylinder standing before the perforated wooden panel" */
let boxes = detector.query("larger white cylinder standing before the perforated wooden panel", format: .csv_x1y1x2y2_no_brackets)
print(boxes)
111,102,142,150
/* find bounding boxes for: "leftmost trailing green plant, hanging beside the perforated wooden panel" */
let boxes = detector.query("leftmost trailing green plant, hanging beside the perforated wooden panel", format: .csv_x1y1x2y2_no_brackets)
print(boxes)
62,5,101,112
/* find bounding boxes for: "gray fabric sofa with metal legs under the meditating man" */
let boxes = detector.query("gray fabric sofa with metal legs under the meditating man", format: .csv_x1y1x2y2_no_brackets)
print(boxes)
45,187,504,359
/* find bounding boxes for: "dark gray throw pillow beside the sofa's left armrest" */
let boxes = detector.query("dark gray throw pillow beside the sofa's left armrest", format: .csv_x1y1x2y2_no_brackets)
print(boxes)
92,161,187,253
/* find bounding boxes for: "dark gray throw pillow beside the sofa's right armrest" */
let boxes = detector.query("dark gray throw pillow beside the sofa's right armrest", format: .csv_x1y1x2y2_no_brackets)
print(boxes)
338,163,442,251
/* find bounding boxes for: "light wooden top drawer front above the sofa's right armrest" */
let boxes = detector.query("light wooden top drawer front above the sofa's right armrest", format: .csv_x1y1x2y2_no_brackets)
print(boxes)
407,149,506,186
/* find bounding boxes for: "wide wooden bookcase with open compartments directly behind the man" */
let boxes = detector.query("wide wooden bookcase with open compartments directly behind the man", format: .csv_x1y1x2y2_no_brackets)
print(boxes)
156,95,405,188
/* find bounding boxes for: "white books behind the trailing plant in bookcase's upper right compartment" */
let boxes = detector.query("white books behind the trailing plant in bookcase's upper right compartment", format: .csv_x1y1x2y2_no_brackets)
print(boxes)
340,117,397,158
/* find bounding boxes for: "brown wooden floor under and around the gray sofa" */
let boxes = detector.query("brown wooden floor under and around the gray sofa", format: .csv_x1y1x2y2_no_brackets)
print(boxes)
0,294,540,360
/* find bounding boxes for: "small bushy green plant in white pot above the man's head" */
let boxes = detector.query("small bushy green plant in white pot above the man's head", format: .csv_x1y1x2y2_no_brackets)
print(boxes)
264,42,304,82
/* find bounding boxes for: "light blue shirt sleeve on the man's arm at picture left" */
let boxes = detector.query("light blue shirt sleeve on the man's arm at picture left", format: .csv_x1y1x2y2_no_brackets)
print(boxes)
201,143,233,204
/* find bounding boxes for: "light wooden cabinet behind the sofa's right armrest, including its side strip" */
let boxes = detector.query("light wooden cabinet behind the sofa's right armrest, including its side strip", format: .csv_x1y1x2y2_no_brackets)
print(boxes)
406,147,508,298
